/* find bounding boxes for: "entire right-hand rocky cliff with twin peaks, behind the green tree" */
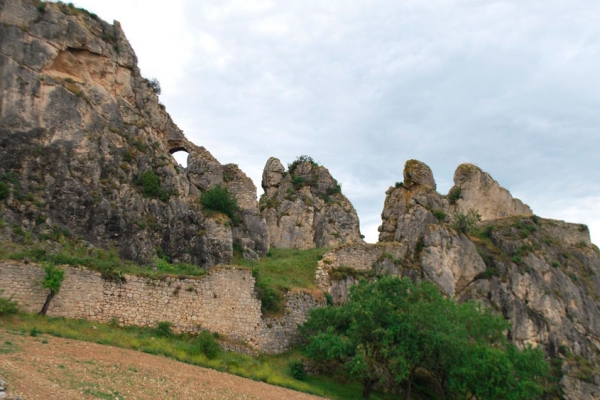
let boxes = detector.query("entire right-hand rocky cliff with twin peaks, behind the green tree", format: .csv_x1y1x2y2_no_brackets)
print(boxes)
317,160,600,399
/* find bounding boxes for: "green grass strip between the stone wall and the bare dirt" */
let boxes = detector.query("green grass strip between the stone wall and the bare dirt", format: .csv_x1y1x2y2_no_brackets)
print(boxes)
0,314,394,400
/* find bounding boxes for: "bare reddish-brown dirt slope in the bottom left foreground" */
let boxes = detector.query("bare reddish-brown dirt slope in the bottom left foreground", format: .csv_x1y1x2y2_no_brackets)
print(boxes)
0,330,321,400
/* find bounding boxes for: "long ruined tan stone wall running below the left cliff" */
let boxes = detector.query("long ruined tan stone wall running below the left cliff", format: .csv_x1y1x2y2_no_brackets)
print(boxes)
0,261,323,353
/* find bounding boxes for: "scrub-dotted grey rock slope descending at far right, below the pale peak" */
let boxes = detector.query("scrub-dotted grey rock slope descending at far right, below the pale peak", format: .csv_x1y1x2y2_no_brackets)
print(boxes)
459,217,600,399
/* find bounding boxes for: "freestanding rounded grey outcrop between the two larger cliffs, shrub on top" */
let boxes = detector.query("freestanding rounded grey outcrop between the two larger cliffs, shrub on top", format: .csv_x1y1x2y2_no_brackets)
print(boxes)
260,157,363,249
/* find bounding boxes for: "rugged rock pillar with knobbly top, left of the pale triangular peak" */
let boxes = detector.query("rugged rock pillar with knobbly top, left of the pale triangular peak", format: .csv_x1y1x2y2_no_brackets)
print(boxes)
379,160,485,295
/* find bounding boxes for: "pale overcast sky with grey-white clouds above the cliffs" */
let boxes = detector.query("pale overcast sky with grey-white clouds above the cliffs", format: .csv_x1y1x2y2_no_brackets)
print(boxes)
65,0,600,244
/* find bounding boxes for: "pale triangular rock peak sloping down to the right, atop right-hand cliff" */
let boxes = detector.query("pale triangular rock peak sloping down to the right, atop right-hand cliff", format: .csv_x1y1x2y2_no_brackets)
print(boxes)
450,164,533,221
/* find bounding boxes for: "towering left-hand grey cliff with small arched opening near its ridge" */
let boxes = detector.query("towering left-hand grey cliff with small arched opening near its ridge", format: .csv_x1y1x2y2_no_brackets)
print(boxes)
0,0,268,267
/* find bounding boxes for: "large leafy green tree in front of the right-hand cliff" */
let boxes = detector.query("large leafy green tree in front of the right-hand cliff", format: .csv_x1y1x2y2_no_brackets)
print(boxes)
301,277,548,400
